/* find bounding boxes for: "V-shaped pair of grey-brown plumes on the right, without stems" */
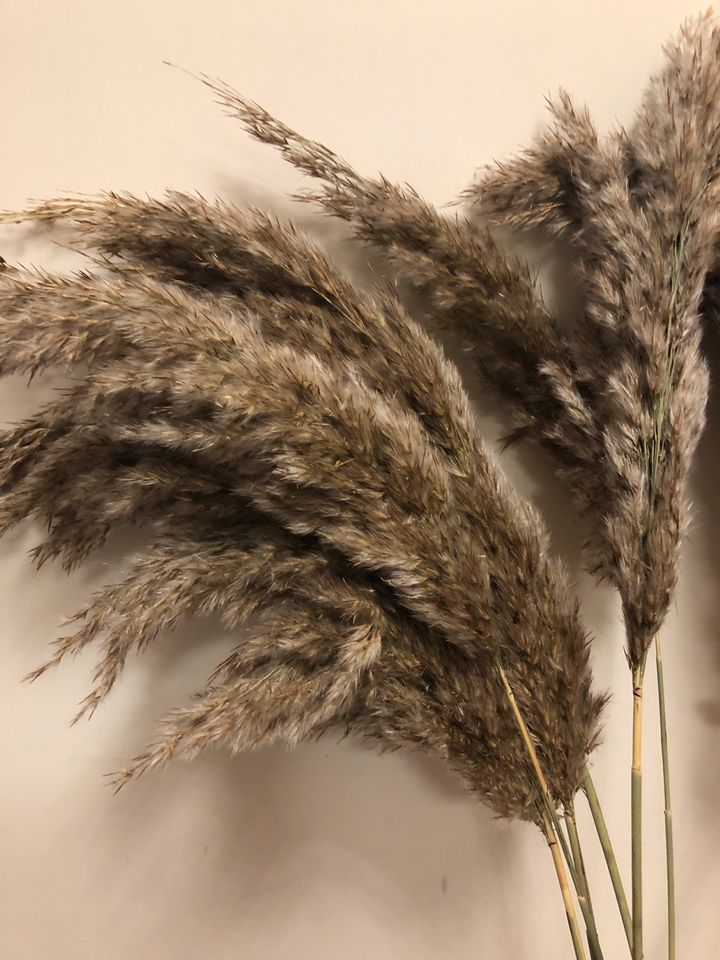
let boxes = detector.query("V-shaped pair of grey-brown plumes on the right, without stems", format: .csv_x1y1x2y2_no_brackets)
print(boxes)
179,19,717,663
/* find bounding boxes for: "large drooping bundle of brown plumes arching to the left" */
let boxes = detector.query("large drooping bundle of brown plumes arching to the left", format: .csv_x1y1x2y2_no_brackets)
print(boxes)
0,210,602,956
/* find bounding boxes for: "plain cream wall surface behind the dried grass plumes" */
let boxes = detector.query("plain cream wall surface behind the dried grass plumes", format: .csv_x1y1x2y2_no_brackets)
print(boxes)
0,0,720,960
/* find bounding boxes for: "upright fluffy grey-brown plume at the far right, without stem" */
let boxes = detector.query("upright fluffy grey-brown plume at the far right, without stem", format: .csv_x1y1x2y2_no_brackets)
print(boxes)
475,15,720,664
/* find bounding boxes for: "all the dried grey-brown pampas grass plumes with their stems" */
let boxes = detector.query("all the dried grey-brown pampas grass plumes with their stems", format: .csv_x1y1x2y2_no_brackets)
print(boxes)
0,11,720,960
